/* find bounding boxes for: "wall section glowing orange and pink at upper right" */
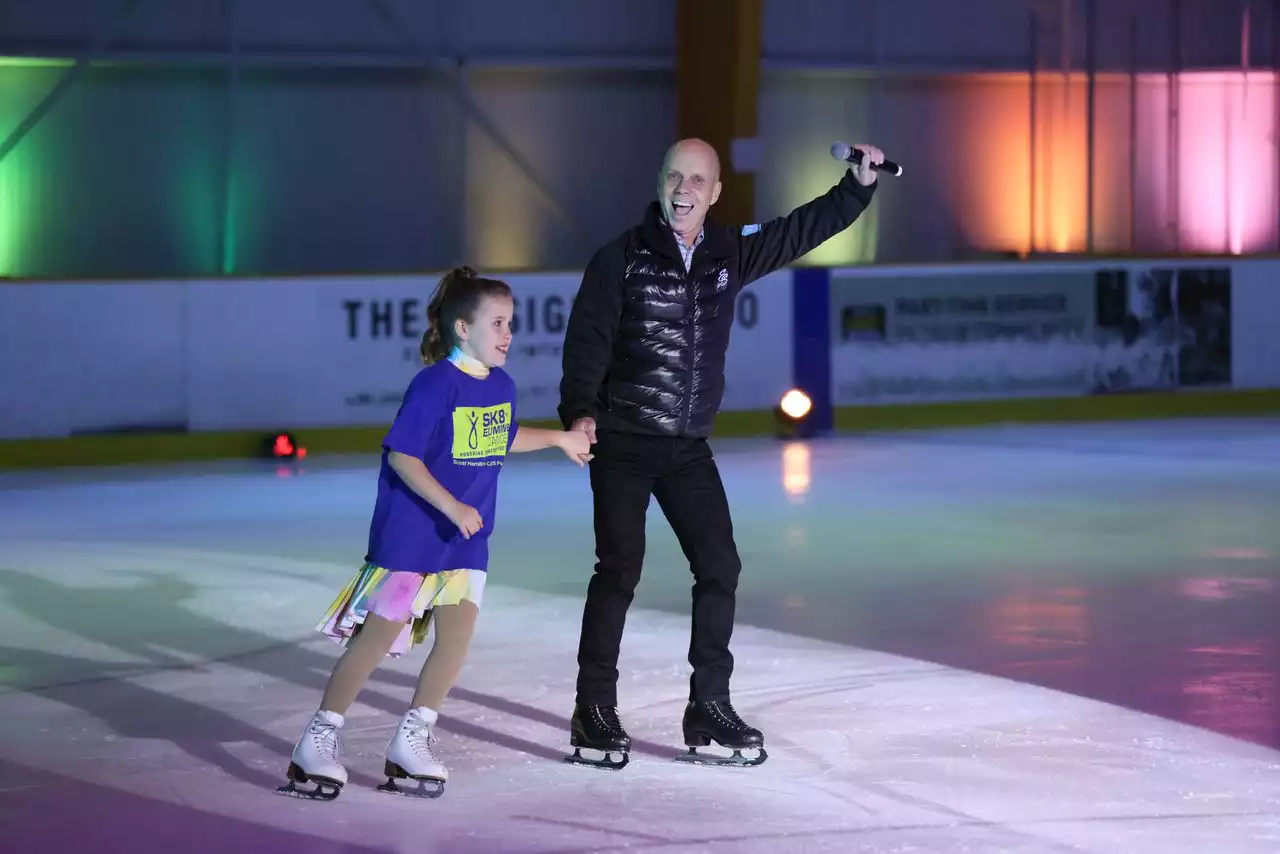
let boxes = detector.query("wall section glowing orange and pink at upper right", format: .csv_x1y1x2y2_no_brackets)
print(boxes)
952,72,1277,254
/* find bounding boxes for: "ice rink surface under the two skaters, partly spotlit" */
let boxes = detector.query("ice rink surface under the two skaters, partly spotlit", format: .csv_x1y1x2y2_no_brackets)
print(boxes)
0,419,1280,854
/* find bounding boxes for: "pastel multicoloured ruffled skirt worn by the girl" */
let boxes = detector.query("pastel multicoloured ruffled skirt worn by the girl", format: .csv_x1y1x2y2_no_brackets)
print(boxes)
316,563,488,658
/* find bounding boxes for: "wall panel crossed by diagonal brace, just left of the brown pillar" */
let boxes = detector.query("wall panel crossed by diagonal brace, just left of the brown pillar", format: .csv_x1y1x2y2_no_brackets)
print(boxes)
465,70,676,269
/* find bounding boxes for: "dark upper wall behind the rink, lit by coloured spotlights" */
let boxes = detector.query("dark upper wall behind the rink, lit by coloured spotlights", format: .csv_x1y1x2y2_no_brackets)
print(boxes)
0,0,1280,278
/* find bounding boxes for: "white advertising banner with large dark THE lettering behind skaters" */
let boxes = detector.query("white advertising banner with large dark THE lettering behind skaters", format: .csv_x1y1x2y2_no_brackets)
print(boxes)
187,271,791,430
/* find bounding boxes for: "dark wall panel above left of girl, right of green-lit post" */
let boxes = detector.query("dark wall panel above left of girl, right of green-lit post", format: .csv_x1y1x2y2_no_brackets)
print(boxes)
233,70,461,274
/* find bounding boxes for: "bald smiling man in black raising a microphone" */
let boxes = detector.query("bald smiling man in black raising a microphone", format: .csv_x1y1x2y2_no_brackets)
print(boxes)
559,140,884,768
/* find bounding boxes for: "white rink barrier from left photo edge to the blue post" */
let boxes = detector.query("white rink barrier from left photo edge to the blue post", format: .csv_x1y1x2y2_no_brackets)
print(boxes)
0,270,792,439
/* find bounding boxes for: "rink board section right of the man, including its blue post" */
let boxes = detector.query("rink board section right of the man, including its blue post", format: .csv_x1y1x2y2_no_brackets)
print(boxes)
796,259,1280,435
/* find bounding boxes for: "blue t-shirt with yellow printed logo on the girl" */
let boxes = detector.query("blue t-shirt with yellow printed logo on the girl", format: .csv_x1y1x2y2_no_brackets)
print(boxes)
365,360,516,572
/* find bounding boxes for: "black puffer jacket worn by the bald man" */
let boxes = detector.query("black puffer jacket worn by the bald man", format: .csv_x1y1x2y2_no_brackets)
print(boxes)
559,166,876,438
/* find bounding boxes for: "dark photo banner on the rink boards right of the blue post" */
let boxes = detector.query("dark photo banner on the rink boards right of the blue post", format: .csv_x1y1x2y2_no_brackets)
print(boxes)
831,264,1231,406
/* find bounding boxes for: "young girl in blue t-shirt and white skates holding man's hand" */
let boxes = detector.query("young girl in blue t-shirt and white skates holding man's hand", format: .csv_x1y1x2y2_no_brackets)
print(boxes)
279,268,590,800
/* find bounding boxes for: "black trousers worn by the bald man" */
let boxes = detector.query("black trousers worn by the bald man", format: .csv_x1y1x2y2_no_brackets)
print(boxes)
577,433,742,705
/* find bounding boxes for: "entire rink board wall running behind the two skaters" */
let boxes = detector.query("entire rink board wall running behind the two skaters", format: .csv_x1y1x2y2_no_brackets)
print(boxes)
0,259,1280,456
